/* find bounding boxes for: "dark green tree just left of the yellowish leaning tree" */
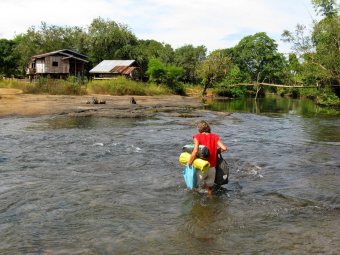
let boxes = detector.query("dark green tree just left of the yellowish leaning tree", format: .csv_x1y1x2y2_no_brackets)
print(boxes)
174,45,207,83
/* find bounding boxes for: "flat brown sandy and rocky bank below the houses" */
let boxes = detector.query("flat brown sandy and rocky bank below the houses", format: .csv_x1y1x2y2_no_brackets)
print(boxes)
0,88,203,117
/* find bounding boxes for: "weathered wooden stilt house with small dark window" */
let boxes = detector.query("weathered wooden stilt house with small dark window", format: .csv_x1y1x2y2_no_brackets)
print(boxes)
26,49,89,79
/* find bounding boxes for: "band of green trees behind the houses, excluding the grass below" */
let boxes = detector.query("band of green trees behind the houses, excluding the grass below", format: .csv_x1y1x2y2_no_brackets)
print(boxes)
0,0,340,100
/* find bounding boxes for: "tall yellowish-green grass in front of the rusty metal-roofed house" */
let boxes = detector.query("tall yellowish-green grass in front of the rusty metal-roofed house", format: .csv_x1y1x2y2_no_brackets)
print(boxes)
87,77,171,96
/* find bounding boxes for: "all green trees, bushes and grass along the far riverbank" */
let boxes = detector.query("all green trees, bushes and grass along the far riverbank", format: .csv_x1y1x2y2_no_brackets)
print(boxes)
0,0,340,108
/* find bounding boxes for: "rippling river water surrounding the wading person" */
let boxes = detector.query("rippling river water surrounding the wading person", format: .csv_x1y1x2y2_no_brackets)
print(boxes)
0,96,340,254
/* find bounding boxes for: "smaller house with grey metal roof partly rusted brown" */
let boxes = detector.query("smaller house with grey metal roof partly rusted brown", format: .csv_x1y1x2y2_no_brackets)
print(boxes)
90,60,139,79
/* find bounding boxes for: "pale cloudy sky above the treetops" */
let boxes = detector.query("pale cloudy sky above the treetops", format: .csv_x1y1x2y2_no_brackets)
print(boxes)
0,0,316,53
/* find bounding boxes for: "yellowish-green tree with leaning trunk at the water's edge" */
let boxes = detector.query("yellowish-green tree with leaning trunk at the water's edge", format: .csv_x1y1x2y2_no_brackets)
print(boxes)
197,50,232,96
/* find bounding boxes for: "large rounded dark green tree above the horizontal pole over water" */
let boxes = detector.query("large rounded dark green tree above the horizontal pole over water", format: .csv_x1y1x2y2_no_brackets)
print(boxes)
232,32,286,83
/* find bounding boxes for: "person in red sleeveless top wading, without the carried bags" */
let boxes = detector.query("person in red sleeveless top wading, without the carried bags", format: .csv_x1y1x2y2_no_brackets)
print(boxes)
188,120,228,195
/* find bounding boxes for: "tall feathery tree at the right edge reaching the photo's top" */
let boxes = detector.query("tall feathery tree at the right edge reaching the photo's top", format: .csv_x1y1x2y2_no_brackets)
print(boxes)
282,0,340,85
